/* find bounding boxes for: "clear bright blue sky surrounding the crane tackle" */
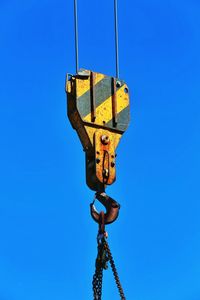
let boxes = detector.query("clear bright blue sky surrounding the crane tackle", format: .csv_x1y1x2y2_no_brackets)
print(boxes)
0,0,200,300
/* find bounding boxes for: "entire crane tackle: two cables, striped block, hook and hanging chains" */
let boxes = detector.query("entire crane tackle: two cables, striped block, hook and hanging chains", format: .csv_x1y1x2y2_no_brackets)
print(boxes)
66,0,130,300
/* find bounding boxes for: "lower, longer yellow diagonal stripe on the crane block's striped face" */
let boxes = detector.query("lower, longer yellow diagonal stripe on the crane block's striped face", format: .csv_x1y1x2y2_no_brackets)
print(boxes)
84,85,129,125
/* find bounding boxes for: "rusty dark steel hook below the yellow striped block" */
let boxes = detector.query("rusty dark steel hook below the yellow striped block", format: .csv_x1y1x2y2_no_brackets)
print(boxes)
90,192,120,225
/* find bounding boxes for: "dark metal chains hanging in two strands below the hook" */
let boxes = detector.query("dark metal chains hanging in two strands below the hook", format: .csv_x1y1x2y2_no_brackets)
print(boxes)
92,234,126,300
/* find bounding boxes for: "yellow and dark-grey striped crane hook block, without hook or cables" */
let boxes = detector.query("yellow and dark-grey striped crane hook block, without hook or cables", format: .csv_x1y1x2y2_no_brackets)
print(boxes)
66,69,130,192
